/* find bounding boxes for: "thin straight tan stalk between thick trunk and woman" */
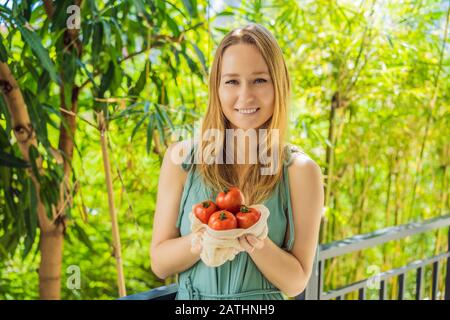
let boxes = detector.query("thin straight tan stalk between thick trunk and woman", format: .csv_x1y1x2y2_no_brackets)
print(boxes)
97,112,126,297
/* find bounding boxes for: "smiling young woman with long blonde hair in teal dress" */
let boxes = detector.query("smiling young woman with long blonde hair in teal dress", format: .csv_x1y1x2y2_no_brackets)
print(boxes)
150,24,323,300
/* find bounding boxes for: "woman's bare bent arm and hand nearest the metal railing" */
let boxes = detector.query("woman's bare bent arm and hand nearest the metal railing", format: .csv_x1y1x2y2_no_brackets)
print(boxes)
240,156,324,297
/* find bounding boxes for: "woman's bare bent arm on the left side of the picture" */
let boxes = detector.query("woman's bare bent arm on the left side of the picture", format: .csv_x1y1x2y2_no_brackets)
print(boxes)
150,142,200,279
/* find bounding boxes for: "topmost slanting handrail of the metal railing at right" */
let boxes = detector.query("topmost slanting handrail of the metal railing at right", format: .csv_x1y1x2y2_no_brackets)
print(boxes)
318,214,450,260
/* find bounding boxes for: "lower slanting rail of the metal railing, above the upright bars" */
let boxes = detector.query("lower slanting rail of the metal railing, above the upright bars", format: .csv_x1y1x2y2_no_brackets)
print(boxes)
321,252,450,300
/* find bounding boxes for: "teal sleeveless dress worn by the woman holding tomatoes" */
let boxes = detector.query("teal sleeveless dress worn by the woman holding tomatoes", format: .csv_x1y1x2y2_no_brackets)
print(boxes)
175,146,304,300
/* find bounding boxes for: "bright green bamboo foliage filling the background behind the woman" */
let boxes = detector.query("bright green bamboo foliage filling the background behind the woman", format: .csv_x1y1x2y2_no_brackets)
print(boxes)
0,0,450,299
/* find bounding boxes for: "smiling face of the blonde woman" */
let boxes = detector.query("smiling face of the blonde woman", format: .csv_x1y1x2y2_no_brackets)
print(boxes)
219,44,275,130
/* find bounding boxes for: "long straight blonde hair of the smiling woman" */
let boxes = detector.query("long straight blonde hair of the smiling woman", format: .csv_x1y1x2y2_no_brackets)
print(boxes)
197,24,291,205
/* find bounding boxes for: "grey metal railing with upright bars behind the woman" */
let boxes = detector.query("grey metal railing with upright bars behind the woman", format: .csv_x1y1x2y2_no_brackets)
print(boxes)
121,214,450,300
